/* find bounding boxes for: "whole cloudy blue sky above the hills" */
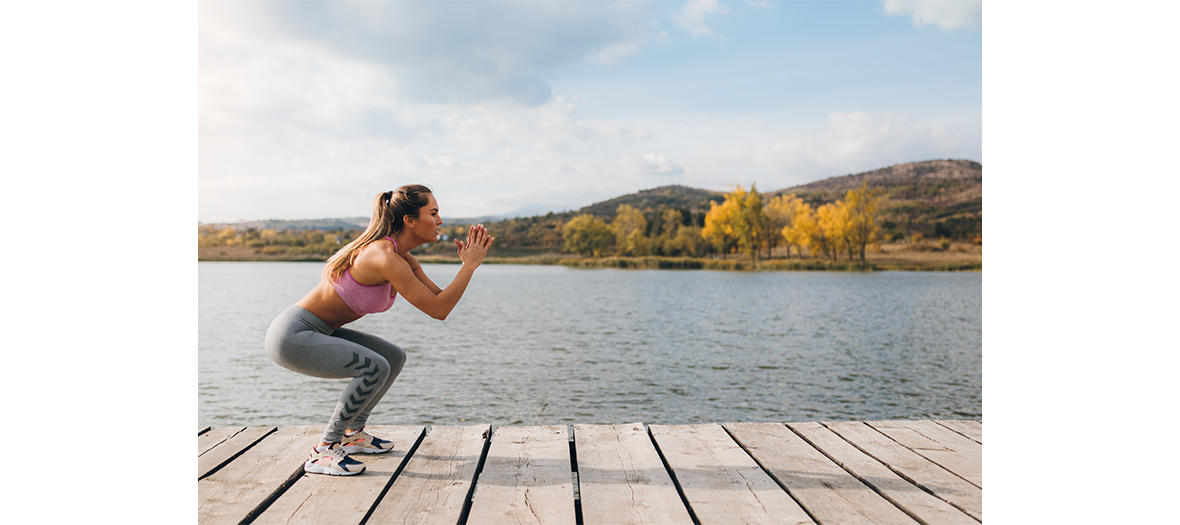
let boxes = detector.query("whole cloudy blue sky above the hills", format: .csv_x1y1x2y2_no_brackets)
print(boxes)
197,0,984,223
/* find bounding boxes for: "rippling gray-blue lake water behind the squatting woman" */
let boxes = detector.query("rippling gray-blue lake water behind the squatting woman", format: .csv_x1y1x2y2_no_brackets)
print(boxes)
197,262,983,427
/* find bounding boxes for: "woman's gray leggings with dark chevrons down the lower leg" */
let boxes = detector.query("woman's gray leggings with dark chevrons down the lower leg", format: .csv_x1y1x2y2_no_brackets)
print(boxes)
267,306,406,442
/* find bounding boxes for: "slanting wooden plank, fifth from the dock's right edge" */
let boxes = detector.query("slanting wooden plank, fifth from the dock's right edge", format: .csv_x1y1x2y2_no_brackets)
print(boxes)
723,424,918,525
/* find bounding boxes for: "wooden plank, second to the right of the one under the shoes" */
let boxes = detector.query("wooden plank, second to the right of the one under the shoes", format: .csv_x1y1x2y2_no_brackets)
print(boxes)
467,425,577,525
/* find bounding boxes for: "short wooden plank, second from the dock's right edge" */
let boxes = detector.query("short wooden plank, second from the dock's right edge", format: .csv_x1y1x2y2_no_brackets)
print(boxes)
868,421,983,488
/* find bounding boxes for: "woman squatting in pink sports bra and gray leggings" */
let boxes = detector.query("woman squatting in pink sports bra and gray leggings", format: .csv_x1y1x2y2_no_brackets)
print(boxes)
267,185,494,475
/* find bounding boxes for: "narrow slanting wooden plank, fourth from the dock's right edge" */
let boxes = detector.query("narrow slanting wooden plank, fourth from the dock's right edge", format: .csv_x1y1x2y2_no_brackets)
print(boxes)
787,422,978,525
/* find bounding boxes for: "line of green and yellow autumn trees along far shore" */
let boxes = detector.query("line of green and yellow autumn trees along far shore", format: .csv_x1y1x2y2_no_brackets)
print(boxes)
198,183,884,264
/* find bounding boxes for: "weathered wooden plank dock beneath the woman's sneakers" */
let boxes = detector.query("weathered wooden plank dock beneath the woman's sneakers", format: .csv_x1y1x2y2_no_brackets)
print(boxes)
197,420,983,525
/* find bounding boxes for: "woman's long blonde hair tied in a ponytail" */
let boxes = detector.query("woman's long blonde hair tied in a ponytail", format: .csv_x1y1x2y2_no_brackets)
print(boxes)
321,184,431,281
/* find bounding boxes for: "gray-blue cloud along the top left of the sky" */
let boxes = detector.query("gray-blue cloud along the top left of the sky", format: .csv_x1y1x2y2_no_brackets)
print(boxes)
205,0,660,106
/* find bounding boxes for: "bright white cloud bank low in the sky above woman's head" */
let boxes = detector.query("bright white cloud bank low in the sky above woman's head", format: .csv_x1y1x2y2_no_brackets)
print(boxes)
198,89,679,221
